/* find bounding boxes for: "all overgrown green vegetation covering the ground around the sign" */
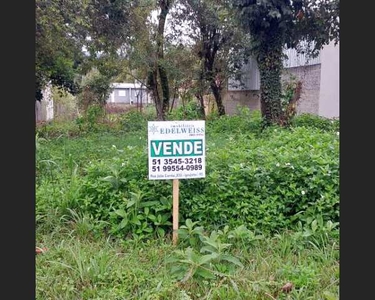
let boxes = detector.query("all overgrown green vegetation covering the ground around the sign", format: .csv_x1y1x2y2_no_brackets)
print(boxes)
36,110,339,300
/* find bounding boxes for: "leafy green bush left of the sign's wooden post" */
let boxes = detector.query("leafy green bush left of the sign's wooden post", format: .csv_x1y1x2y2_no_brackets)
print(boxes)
37,143,171,237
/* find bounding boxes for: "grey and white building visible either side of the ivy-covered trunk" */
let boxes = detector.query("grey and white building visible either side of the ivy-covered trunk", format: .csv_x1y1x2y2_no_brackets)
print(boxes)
223,42,340,118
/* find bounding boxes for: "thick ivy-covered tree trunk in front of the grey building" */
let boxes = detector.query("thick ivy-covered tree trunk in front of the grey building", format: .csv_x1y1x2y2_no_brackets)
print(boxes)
257,34,283,125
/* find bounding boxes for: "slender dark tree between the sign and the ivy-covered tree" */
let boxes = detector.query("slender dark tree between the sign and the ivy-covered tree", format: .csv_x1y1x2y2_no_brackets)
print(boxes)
175,0,251,115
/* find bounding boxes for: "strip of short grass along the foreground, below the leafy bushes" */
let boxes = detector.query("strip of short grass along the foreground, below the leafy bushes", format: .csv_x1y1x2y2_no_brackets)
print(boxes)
36,225,339,300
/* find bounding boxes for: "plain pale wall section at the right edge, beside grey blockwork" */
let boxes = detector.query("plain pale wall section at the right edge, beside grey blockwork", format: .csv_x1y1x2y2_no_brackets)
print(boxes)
319,42,340,118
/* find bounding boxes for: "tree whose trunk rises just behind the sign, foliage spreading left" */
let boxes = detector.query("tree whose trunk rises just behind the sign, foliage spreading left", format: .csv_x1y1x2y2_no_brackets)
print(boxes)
88,0,173,120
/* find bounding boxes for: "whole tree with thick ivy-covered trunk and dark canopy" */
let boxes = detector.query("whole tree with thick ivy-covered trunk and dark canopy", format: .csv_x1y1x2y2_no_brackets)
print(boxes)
234,0,339,124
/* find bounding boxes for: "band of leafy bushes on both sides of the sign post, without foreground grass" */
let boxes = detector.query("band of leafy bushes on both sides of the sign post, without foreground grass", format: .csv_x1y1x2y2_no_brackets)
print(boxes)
37,113,339,236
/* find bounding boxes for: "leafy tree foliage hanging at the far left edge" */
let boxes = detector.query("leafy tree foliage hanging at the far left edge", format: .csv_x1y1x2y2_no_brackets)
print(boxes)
35,0,88,100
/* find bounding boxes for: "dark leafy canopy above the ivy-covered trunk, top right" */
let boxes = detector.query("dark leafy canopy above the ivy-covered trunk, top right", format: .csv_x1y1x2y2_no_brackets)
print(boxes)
233,0,340,54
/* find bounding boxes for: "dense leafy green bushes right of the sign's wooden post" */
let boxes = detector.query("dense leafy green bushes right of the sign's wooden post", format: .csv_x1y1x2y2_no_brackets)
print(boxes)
181,128,339,230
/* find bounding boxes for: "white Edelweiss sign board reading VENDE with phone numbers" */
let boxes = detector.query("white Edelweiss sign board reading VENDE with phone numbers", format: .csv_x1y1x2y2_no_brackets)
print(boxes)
148,121,206,180
